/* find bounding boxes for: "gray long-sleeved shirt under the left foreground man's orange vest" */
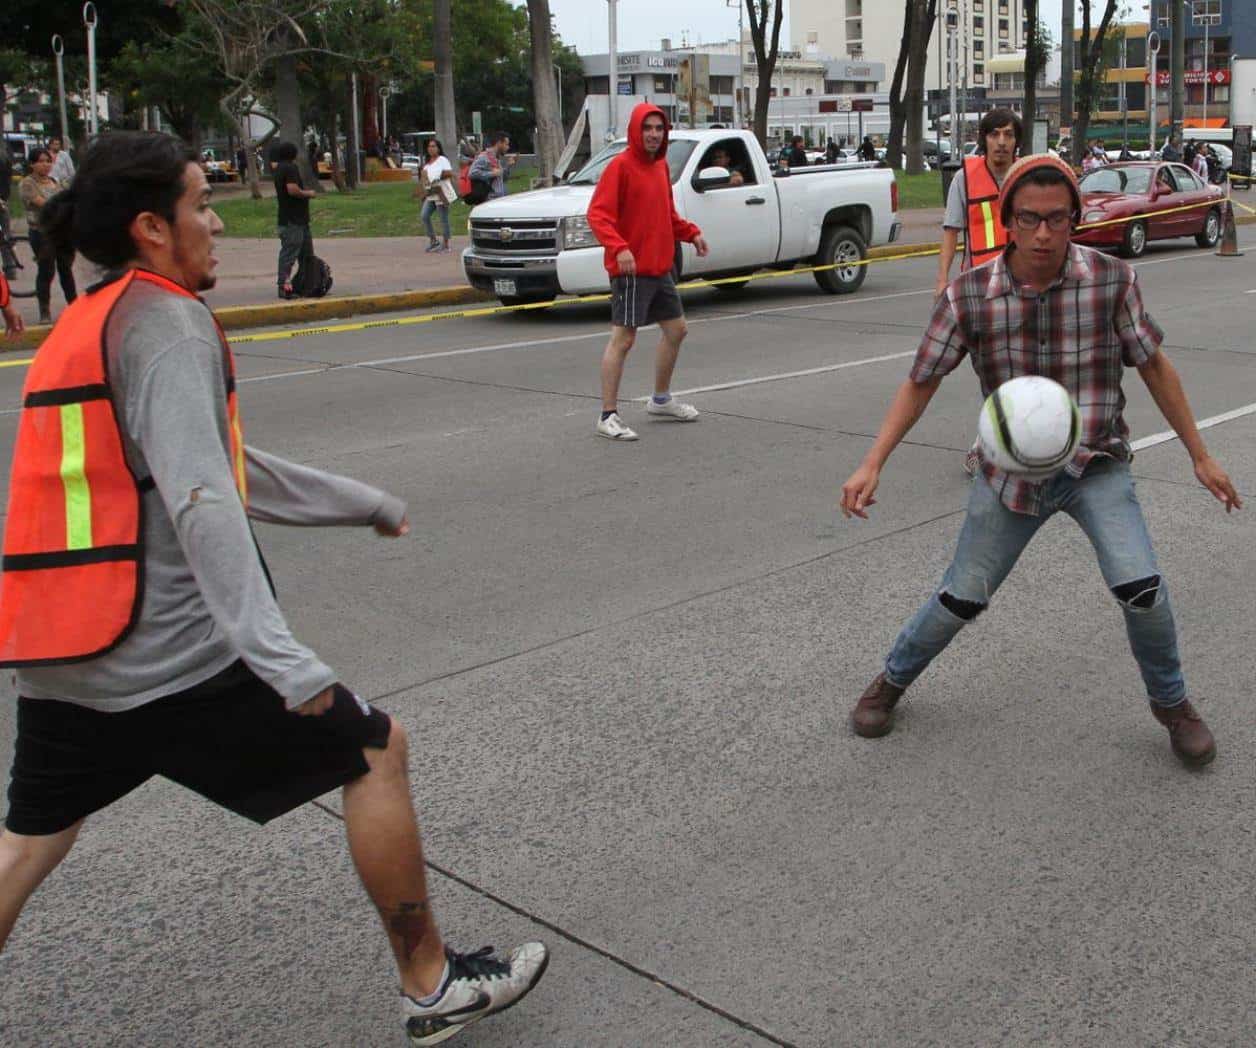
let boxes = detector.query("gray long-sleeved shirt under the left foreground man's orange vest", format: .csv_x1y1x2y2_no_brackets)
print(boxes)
18,275,406,712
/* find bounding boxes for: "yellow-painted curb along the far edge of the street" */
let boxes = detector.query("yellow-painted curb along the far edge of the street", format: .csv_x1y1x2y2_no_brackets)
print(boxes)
0,215,1256,354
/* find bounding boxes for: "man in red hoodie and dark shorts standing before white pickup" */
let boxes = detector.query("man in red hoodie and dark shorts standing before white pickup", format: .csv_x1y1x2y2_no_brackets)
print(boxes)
589,102,707,440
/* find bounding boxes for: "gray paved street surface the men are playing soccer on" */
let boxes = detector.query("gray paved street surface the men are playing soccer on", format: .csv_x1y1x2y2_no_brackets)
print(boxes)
0,227,1256,1048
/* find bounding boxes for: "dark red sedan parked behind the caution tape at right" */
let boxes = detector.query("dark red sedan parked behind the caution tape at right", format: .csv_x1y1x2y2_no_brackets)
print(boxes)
1073,161,1226,259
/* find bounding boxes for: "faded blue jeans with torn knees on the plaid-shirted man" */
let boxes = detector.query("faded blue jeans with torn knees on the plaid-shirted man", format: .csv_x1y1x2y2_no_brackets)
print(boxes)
885,457,1186,706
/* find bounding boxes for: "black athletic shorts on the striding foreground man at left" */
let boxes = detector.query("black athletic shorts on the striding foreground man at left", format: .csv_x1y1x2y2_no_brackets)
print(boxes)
5,662,391,837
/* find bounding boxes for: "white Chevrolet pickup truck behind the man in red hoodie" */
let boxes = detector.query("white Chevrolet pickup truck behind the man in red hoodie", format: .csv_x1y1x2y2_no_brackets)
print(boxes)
462,131,899,304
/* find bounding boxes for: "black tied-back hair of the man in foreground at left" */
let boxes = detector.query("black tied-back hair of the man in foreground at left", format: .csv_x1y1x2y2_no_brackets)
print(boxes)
40,131,197,269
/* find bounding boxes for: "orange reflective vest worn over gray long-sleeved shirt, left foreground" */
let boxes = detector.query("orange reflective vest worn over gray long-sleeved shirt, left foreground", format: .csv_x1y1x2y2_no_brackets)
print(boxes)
0,269,247,666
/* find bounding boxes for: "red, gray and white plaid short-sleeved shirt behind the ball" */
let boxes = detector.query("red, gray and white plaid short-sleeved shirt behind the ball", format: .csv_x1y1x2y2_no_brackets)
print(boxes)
912,244,1164,514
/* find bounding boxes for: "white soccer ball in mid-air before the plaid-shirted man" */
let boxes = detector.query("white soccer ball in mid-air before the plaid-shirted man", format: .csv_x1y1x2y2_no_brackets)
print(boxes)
977,374,1081,480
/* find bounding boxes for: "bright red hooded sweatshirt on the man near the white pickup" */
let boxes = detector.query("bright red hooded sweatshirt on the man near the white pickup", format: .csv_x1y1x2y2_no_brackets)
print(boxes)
589,102,702,276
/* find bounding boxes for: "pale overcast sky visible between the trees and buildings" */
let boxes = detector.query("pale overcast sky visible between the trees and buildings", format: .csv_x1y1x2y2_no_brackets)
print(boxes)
519,0,1070,64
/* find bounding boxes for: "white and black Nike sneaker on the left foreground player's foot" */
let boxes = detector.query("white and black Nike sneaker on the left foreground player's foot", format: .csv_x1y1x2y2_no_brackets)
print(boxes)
401,942,549,1044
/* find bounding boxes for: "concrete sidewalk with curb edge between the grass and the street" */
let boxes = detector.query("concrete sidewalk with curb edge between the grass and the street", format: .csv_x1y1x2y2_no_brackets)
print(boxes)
14,207,943,346
